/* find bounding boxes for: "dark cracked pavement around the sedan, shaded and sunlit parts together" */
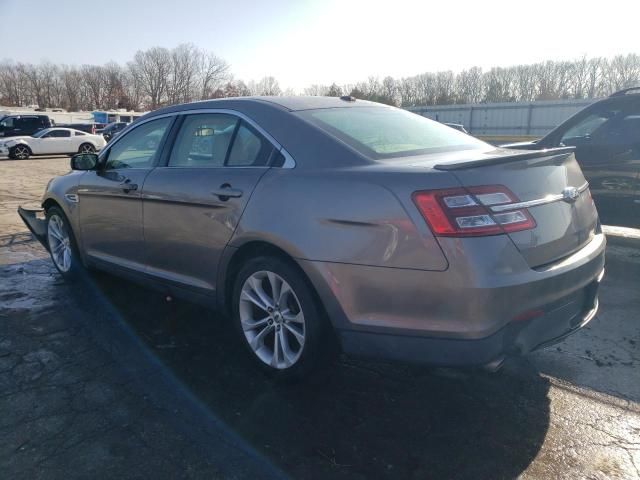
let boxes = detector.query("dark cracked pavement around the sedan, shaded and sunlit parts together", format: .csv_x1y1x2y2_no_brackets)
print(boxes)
0,158,640,480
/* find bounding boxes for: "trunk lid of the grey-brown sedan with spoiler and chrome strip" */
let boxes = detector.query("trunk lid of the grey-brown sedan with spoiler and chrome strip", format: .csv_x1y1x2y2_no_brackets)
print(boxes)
434,149,598,268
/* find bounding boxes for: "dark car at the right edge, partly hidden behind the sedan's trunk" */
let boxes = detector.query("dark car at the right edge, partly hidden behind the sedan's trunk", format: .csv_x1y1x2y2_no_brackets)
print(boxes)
503,87,640,228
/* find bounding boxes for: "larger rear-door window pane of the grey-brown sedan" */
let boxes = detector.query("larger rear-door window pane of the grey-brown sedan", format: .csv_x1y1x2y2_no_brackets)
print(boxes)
169,113,238,167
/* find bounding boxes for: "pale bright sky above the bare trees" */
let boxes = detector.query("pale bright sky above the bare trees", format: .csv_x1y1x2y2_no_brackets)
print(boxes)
0,0,640,90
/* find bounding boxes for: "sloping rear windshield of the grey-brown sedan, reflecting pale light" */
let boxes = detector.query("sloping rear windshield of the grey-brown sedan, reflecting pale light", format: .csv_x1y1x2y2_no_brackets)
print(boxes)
299,107,487,158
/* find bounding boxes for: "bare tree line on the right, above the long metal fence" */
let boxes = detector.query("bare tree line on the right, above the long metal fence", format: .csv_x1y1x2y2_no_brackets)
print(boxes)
305,54,640,107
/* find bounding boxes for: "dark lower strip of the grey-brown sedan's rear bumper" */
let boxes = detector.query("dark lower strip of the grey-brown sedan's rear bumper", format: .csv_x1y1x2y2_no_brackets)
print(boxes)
340,270,604,367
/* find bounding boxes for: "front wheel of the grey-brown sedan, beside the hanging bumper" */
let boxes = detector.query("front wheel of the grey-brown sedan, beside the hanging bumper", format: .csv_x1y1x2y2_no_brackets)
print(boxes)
47,207,84,282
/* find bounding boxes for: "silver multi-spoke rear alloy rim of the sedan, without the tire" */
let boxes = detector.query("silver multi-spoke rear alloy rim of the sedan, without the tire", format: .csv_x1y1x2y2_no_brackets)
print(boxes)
239,271,305,370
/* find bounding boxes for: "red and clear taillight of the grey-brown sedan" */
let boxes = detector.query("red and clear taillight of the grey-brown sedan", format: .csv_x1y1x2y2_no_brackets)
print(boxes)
413,185,536,237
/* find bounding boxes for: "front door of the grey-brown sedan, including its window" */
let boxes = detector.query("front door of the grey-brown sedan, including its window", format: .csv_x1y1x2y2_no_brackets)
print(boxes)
78,117,173,270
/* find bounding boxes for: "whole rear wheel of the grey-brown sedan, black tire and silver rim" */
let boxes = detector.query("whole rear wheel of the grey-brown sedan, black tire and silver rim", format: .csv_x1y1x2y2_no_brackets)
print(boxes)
231,257,331,380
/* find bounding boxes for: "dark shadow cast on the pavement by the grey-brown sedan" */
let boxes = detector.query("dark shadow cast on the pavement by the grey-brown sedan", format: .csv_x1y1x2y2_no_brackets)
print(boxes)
66,274,550,479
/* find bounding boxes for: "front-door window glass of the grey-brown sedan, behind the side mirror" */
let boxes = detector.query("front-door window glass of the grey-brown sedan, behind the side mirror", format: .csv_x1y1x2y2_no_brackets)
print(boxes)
105,117,172,170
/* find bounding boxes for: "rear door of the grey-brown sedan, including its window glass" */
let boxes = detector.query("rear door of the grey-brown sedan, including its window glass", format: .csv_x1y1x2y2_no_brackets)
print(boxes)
143,113,274,293
